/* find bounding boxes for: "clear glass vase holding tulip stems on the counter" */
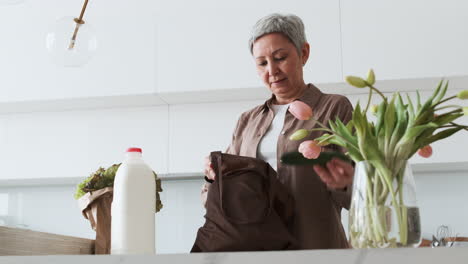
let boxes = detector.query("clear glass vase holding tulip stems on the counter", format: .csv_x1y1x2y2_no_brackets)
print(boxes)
349,160,421,248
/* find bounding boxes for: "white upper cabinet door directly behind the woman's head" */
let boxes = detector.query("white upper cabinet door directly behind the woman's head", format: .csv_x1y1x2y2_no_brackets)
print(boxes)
156,0,342,93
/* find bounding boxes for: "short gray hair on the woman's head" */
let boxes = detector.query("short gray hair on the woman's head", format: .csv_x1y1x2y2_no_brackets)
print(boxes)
249,13,307,55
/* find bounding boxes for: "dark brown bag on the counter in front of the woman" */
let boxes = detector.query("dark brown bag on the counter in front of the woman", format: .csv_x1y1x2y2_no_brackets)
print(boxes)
191,152,298,252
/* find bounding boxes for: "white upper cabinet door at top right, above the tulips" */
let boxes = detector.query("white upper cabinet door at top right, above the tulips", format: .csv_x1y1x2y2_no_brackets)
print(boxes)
341,0,468,80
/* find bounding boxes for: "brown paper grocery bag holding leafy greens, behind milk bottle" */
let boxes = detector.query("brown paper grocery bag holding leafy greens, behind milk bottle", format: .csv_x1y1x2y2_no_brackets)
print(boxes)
78,187,113,254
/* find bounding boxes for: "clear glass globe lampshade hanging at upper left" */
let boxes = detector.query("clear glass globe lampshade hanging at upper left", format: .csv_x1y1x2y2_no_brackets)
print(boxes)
46,17,97,67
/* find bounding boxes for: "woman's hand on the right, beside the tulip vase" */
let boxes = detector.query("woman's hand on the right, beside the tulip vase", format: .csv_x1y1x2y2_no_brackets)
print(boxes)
314,158,354,190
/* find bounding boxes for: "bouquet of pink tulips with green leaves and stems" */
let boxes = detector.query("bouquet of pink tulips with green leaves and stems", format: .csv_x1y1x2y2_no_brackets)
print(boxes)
282,70,468,248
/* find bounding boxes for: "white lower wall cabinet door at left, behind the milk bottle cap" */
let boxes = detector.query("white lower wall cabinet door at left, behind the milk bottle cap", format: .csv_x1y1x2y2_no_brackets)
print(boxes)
0,106,168,179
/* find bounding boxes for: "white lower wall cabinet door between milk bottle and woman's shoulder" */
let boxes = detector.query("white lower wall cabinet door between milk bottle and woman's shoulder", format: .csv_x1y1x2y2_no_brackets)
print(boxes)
168,101,263,176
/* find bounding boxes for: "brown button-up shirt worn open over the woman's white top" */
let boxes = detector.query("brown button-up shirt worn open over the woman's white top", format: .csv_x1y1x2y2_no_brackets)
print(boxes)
203,84,353,249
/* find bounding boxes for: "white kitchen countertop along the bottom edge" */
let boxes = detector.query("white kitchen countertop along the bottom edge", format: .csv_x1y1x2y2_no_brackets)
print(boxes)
0,247,468,264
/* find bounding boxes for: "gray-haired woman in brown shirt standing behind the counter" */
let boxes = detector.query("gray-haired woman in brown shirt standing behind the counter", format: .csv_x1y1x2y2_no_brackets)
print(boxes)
202,14,354,249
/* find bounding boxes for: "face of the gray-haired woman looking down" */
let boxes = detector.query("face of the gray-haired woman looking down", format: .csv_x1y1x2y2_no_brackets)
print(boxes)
252,33,309,103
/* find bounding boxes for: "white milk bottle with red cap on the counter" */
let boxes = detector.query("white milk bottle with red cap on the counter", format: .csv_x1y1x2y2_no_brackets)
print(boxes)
111,148,156,254
